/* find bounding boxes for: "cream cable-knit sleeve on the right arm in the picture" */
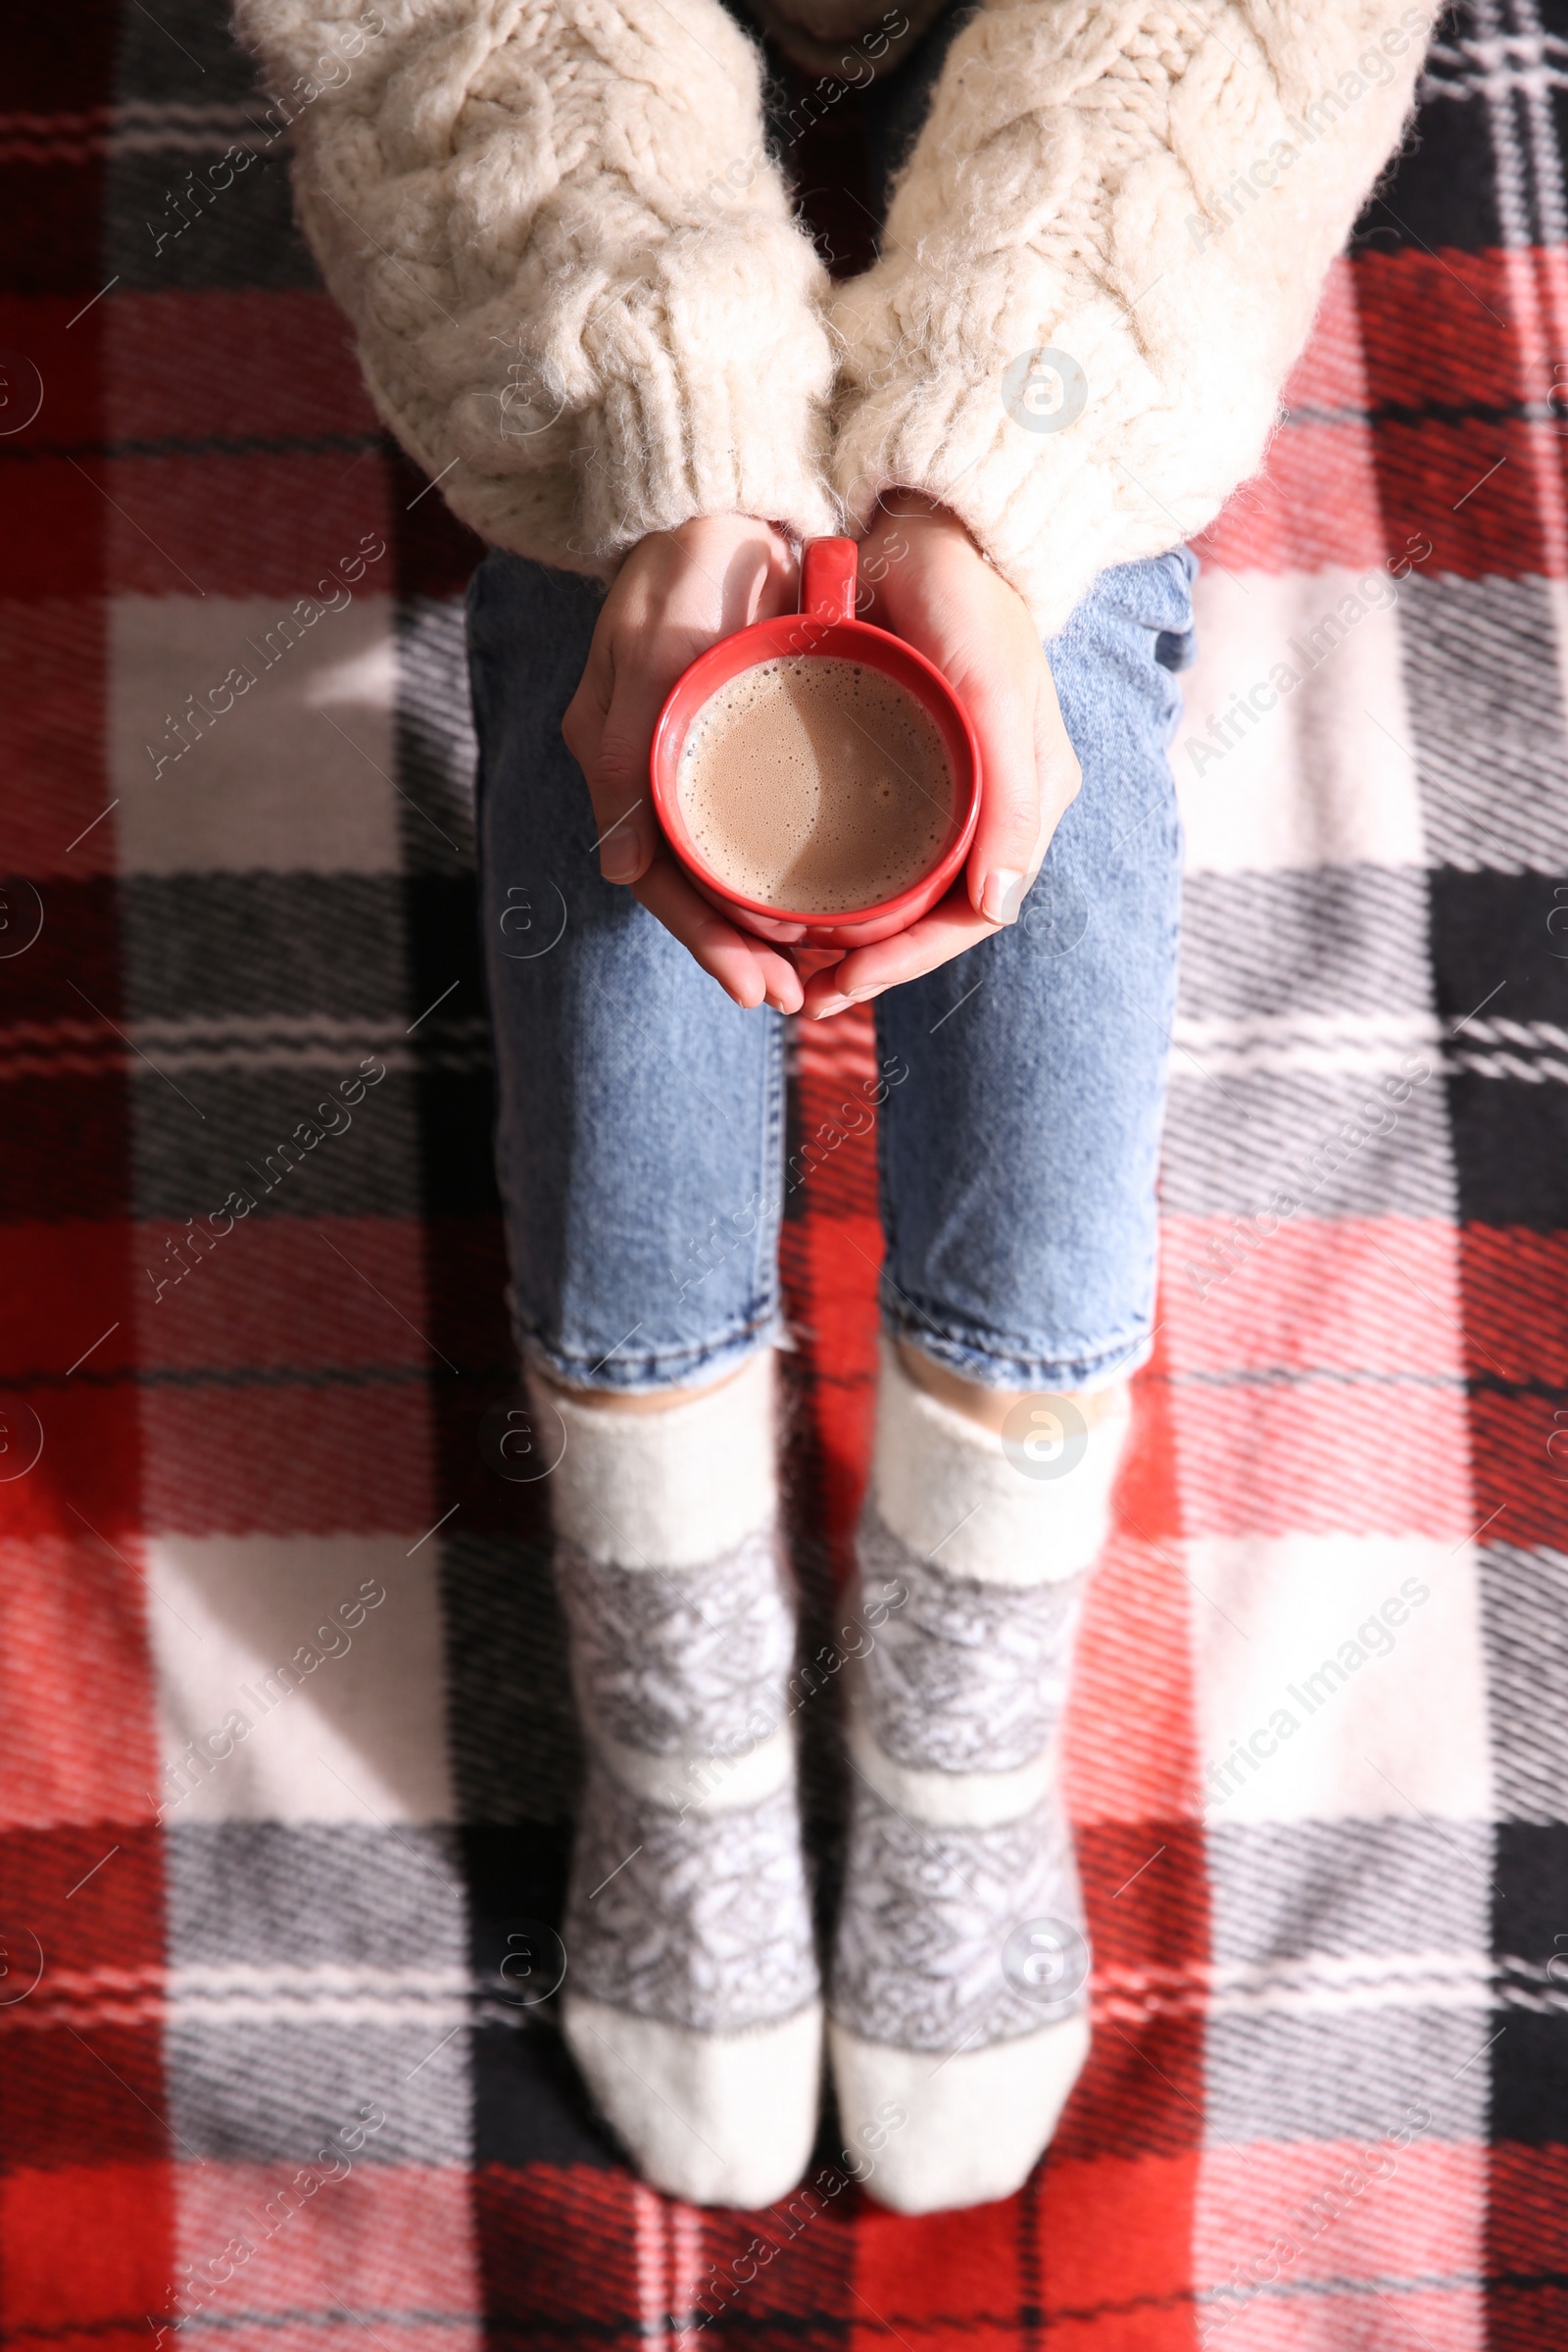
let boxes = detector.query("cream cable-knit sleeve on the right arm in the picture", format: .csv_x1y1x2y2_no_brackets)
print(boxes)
832,0,1432,635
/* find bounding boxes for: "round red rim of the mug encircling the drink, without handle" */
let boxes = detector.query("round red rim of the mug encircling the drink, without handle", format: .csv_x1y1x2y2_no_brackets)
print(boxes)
649,612,980,946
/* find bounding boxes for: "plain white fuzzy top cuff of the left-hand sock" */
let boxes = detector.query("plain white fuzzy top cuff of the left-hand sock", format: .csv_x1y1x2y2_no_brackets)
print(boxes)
534,1348,778,1569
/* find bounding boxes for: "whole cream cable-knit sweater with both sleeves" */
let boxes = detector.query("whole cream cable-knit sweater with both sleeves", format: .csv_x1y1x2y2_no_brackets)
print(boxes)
237,0,1432,633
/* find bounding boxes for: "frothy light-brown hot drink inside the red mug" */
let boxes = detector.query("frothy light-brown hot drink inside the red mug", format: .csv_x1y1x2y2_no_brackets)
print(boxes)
677,654,956,915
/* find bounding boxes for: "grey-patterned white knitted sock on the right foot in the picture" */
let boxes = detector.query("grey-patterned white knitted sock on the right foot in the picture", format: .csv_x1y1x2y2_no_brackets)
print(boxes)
827,1350,1126,2213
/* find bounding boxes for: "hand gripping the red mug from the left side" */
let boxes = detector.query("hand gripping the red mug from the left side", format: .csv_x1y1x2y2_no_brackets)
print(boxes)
562,515,804,1013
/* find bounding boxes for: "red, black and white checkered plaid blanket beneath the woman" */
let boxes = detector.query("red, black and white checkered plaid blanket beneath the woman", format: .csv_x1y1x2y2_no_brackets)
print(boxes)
0,0,1568,2352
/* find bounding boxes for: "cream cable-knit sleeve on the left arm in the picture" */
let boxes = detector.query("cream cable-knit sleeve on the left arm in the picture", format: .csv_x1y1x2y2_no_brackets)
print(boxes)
235,0,832,571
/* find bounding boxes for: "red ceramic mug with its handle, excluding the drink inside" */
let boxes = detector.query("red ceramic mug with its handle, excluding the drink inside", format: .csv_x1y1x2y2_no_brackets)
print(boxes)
651,539,980,962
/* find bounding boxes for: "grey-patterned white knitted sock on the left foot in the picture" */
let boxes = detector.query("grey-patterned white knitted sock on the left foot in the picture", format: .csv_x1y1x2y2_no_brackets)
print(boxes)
553,1352,823,2206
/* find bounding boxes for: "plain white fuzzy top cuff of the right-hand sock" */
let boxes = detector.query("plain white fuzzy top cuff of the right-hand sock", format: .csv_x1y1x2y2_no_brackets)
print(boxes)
872,1343,1131,1586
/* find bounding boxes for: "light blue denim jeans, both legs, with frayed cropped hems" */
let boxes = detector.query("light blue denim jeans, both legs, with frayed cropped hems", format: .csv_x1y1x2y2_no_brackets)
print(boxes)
467,551,1197,1390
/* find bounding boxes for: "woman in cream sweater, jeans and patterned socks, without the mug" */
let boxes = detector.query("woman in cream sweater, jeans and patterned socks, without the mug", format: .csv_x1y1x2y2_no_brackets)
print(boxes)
240,0,1429,2211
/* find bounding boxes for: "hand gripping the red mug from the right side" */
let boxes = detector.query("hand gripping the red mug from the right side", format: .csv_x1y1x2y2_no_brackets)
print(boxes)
804,492,1079,1021
